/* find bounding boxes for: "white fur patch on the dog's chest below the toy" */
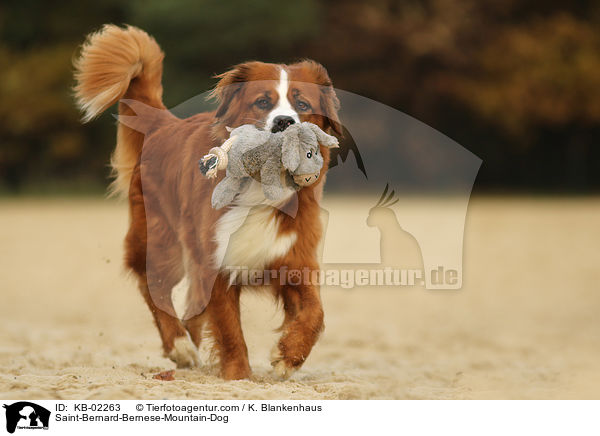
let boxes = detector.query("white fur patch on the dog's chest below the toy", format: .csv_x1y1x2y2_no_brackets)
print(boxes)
214,181,297,270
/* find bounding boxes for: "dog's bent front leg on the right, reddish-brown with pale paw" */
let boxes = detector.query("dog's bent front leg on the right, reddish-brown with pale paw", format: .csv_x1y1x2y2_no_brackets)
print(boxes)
271,277,323,378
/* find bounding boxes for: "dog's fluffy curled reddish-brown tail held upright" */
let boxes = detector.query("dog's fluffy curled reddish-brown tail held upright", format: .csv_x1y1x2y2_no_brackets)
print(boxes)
74,24,165,193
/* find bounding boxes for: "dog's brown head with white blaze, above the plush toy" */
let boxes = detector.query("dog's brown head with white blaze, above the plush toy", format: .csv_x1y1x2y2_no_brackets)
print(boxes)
211,60,342,140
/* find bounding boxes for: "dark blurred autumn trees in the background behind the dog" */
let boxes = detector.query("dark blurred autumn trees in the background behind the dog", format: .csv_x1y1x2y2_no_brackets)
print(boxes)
0,0,600,193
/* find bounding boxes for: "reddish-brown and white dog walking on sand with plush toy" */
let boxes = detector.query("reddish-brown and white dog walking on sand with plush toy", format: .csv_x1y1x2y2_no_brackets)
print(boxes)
75,25,341,379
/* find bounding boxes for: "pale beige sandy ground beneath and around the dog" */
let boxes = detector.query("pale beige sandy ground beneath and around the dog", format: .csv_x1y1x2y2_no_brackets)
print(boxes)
0,198,600,399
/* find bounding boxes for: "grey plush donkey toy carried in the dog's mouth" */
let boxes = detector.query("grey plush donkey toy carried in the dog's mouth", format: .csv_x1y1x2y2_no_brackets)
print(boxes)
199,122,338,209
